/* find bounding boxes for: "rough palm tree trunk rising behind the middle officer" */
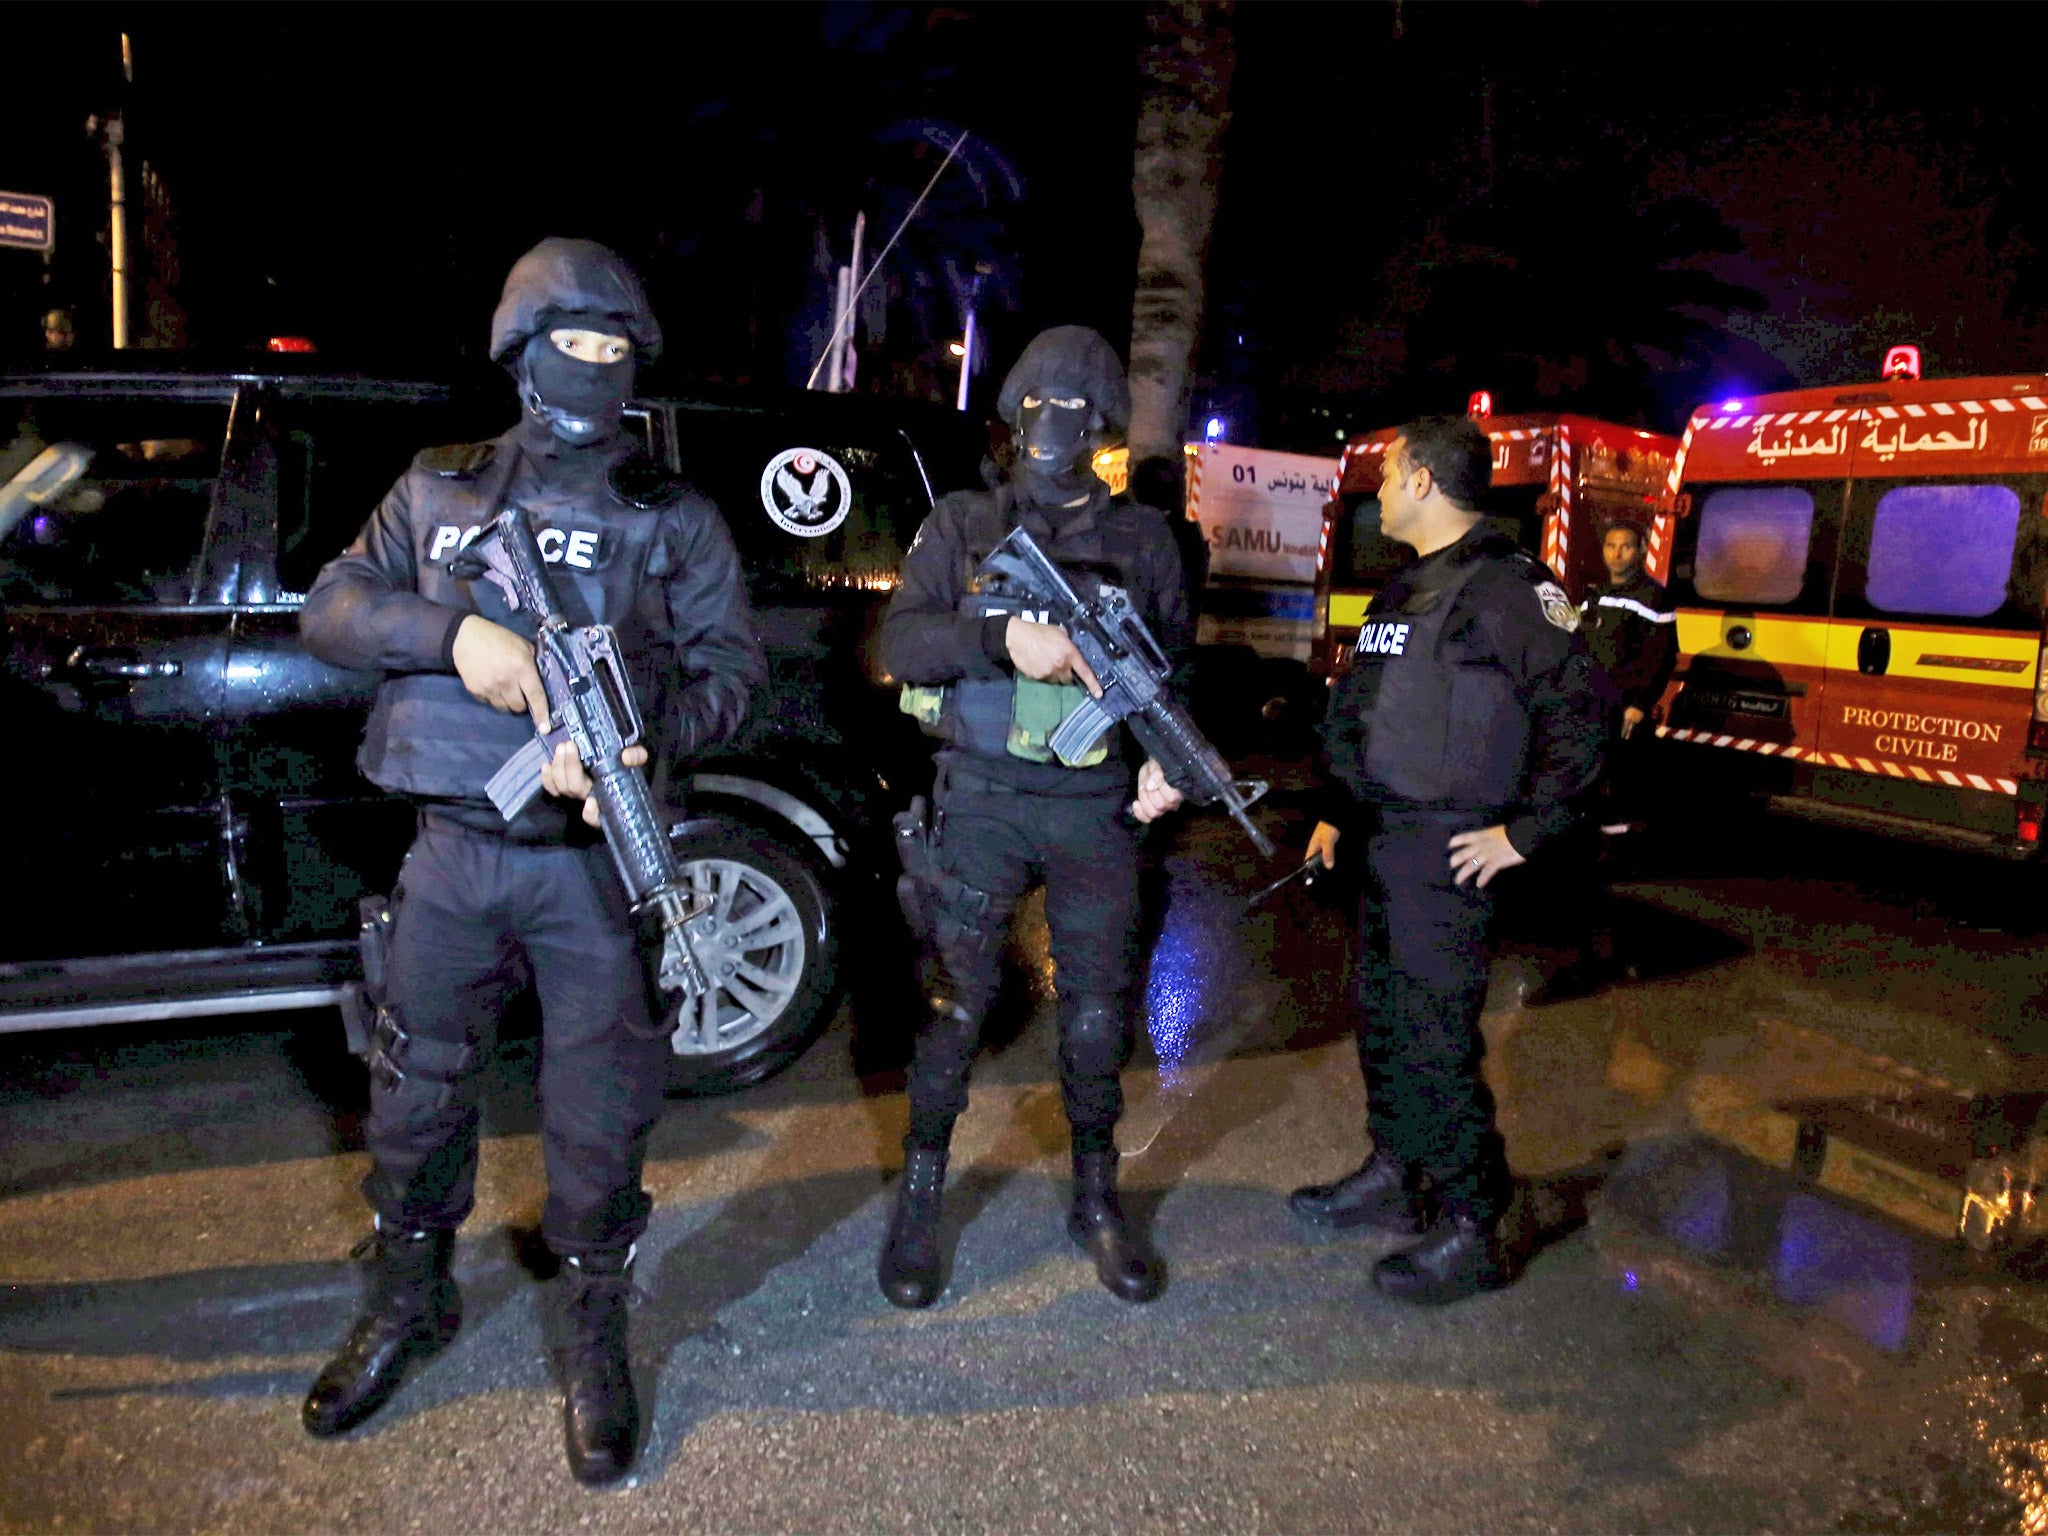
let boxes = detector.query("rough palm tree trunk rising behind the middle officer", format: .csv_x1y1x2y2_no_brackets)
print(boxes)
1130,0,1237,463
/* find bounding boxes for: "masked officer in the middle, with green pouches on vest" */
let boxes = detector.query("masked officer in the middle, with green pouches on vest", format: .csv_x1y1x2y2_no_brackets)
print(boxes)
879,326,1190,1307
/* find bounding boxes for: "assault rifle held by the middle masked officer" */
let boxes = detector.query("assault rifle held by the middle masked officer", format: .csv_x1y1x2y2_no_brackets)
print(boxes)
979,528,1274,858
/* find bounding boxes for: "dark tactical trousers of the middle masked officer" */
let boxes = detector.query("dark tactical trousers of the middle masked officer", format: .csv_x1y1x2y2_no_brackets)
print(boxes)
903,770,1139,1151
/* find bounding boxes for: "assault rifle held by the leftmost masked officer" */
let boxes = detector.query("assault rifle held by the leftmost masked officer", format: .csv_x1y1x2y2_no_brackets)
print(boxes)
449,506,713,1034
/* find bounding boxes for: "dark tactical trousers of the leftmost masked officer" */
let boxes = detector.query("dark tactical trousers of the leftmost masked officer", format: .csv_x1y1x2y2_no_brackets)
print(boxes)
362,813,668,1257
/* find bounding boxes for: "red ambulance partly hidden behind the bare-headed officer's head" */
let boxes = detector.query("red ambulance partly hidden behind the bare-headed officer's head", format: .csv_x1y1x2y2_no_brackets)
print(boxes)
1309,391,1679,680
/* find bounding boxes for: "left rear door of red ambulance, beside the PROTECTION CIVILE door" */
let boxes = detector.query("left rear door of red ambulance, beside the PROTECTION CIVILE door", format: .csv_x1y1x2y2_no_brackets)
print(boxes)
1659,410,1849,772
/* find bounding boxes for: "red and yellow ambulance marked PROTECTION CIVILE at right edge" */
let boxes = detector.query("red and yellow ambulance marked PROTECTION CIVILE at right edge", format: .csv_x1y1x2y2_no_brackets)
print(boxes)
1657,346,2048,858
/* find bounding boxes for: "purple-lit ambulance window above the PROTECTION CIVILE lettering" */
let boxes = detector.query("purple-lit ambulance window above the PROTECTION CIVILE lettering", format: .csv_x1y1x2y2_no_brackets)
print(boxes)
1864,485,2019,618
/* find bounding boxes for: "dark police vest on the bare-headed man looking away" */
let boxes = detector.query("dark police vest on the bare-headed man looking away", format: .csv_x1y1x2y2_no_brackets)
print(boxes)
1352,559,1530,811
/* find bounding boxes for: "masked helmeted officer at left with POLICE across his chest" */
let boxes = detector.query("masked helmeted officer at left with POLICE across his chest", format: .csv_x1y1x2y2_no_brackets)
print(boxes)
301,240,766,1483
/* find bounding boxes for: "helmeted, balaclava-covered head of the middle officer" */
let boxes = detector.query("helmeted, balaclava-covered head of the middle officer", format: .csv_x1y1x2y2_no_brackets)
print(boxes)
995,326,1130,508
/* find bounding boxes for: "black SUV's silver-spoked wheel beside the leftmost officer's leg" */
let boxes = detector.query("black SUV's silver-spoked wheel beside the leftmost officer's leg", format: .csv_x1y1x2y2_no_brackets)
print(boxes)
668,819,840,1094
